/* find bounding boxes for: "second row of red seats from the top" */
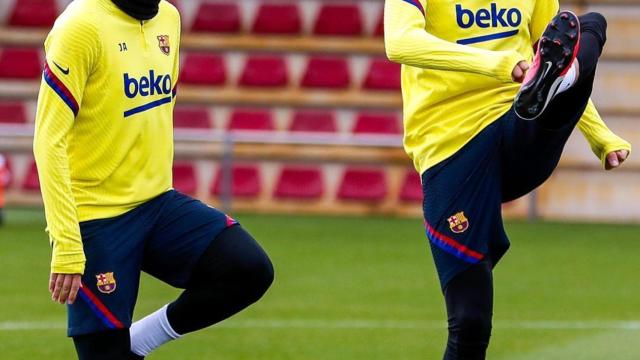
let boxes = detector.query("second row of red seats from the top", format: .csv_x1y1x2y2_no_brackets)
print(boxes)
0,48,400,90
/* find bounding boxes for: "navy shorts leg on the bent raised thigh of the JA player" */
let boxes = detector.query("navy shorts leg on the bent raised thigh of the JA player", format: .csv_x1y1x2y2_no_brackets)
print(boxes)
142,191,237,288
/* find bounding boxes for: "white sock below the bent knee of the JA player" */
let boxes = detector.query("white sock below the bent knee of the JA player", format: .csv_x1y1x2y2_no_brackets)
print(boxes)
129,305,180,356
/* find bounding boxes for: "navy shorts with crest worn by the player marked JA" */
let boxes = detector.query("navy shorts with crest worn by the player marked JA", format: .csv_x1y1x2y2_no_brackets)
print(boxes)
68,190,237,336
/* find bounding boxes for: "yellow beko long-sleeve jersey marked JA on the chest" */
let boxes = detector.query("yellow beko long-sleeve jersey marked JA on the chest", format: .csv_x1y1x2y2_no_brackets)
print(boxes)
34,0,180,273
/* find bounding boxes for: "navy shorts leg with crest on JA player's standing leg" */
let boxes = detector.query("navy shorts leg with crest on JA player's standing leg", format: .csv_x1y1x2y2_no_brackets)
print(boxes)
68,209,145,336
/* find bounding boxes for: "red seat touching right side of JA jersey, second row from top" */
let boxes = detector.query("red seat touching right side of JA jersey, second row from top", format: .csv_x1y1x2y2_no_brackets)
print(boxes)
180,53,227,85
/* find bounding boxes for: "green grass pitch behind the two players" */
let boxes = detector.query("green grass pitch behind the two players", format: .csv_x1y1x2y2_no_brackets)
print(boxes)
0,210,640,360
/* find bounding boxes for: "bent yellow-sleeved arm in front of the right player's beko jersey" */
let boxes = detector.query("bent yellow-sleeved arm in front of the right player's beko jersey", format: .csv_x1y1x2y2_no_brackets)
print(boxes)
384,0,525,82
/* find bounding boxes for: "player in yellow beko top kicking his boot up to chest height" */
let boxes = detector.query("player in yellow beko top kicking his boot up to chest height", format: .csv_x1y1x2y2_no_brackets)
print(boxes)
384,0,631,360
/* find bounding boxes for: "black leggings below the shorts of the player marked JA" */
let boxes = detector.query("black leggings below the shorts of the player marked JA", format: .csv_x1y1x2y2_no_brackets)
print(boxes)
73,225,273,360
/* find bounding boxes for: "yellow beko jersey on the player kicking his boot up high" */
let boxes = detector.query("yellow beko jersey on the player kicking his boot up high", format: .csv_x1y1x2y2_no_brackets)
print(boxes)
384,0,631,173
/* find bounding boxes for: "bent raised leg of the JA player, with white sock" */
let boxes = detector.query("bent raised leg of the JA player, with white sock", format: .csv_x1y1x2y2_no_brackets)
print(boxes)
131,191,274,358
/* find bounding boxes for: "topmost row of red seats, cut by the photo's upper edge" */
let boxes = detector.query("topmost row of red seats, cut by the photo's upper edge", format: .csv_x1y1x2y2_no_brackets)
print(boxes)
7,0,383,36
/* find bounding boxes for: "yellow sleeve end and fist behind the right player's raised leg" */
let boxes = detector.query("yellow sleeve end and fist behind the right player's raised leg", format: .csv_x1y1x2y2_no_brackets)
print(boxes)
578,100,631,167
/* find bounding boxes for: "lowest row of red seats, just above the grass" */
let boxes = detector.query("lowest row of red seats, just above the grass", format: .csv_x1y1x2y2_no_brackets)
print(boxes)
8,162,422,202
